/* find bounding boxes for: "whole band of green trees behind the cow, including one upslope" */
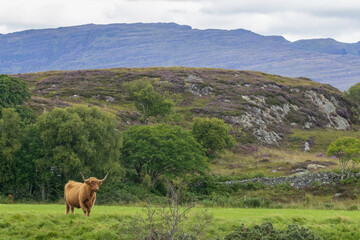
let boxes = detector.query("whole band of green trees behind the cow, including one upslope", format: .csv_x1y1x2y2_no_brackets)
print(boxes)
0,75,235,201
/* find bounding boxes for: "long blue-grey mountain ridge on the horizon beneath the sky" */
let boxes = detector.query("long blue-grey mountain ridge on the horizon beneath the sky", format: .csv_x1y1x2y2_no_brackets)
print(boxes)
0,23,360,90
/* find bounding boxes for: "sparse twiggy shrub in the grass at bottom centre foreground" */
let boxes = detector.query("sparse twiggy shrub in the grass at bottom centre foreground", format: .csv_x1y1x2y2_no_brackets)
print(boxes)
130,182,212,240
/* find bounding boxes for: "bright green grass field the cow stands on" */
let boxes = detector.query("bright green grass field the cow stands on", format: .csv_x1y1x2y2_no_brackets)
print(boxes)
0,204,360,240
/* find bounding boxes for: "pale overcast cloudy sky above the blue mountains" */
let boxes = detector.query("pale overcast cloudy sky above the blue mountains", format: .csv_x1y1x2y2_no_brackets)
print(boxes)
0,0,360,42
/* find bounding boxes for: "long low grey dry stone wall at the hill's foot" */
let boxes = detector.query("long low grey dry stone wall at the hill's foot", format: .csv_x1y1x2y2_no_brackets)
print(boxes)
225,172,341,188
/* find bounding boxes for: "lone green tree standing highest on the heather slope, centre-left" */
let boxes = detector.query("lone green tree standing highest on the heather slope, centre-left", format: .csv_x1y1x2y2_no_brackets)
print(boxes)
125,79,174,122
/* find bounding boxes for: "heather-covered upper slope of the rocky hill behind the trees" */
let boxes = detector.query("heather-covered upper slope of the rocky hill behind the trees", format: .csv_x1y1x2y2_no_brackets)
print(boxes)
16,68,357,144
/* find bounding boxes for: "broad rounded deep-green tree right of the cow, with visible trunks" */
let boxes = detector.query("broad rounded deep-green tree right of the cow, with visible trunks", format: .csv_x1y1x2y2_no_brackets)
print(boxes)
121,124,207,187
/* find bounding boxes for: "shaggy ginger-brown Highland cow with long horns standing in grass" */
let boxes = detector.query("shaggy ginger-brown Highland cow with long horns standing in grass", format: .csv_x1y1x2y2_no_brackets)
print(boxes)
64,173,108,216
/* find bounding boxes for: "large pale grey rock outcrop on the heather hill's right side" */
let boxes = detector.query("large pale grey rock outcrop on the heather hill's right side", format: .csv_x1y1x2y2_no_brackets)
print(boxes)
225,86,350,144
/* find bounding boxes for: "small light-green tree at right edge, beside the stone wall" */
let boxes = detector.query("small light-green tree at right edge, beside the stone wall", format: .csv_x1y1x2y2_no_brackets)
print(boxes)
327,137,360,178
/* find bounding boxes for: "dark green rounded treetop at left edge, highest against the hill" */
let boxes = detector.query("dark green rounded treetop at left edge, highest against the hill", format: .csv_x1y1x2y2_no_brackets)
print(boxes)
0,74,31,108
